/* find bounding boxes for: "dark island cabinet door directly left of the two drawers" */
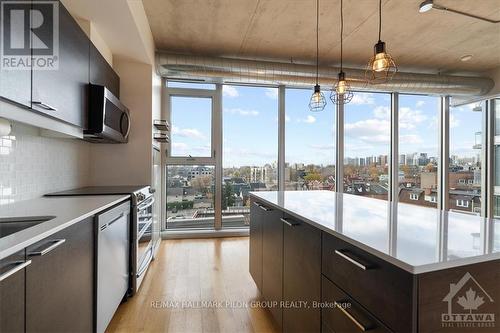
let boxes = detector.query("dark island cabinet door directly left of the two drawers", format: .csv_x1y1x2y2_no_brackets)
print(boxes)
283,215,321,333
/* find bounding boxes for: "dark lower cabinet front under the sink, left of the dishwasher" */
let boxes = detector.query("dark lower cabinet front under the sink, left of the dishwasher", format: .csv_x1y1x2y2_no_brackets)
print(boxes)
0,250,29,332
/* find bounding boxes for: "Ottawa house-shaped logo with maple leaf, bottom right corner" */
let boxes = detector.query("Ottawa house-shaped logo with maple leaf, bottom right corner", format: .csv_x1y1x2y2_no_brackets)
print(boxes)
441,273,495,328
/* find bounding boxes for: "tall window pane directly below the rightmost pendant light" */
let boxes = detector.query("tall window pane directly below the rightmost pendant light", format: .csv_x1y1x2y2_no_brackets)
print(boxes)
344,92,391,200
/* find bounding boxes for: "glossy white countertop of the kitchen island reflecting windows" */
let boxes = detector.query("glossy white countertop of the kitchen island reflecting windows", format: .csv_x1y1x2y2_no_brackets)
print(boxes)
251,191,500,274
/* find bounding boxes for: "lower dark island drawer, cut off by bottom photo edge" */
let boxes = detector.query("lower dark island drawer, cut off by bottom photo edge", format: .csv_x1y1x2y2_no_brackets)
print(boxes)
321,276,391,333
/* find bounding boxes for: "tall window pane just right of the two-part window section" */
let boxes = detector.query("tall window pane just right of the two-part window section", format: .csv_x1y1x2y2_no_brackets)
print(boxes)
222,85,278,228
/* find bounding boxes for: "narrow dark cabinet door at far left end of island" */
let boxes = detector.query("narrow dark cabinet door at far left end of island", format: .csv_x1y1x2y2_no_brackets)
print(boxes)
250,200,264,292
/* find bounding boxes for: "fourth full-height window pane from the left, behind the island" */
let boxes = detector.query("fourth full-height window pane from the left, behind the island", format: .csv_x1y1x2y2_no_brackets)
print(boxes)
398,94,441,207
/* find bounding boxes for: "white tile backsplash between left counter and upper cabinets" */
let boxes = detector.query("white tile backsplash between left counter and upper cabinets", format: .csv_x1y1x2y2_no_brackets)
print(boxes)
0,123,90,205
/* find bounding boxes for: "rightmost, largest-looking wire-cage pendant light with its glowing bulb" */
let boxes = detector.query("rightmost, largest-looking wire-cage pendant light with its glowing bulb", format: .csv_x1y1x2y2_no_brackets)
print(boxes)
365,0,398,84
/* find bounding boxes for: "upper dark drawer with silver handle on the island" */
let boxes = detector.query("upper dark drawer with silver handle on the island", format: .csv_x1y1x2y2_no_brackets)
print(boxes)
322,232,416,332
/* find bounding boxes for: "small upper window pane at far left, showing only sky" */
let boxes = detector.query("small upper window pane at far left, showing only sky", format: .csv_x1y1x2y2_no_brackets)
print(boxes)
170,96,212,157
